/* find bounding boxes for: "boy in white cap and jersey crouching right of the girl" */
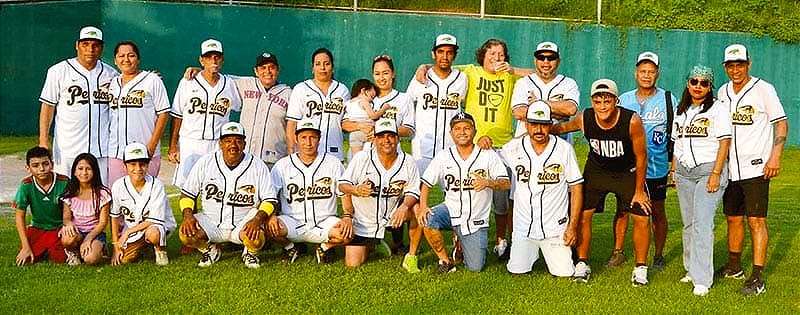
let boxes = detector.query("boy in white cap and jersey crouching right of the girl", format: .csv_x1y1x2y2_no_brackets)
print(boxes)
110,143,177,266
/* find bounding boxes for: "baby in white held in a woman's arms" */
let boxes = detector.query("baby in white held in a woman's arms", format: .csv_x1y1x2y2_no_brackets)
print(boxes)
345,79,390,156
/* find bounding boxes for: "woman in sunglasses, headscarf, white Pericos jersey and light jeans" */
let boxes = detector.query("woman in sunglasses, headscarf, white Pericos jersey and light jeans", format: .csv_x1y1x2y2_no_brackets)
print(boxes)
670,65,731,296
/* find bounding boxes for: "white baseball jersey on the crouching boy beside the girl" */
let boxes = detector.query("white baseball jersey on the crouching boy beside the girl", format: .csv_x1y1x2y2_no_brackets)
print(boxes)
109,175,177,244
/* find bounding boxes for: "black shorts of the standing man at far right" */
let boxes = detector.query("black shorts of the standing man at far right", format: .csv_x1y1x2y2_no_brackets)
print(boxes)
722,176,769,218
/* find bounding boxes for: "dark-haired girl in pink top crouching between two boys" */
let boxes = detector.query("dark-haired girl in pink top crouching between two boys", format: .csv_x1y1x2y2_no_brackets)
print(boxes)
61,153,111,266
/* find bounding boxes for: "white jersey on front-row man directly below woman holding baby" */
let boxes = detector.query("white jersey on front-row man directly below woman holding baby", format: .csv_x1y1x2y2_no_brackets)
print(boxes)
339,149,420,238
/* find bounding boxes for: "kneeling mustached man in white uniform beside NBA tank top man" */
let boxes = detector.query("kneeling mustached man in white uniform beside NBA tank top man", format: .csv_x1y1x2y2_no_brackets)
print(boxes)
502,100,583,277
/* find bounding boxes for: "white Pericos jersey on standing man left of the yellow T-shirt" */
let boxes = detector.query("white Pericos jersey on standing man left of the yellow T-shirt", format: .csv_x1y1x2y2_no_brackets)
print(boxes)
406,68,467,160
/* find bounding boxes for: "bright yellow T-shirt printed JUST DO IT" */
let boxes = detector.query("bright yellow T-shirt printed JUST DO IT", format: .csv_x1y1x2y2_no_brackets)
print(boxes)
455,65,520,148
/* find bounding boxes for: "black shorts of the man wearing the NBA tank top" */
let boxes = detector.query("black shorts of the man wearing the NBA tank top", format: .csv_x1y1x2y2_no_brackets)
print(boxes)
583,163,648,215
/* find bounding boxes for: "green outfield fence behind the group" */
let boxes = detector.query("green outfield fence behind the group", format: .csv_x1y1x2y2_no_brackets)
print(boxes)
0,0,800,144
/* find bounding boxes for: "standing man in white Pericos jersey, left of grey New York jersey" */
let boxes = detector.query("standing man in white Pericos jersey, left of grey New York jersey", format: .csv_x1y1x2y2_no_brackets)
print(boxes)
169,39,242,187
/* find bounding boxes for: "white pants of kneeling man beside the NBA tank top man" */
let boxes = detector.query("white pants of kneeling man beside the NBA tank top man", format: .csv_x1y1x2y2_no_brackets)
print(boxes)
506,231,575,277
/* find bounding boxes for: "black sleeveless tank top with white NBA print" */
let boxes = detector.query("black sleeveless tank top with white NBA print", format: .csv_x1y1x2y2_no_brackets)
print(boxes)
583,107,636,171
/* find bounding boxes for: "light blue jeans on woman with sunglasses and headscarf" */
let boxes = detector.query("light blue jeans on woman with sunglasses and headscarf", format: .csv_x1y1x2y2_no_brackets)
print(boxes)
675,162,728,287
